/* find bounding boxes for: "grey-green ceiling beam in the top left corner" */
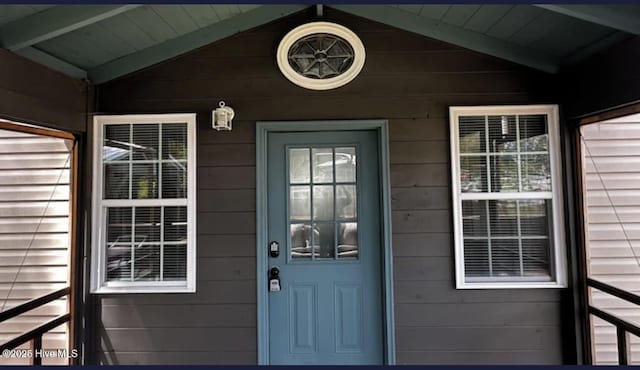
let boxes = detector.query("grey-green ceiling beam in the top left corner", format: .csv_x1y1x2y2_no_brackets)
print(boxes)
0,5,141,51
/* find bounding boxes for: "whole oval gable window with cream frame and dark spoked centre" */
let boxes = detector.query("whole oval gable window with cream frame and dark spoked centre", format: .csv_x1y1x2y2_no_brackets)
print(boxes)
277,22,365,90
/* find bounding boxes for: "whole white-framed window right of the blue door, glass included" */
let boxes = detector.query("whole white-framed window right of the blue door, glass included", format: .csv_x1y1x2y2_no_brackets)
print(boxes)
449,105,566,289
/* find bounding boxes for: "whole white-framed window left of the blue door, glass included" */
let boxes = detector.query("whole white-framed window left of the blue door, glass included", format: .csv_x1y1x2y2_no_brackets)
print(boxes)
91,114,196,293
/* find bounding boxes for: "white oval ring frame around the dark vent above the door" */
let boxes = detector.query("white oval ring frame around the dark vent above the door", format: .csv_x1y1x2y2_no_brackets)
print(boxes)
277,22,366,90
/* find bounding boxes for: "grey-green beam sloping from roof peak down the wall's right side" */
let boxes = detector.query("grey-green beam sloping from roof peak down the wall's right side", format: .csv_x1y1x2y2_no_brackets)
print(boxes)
331,5,558,73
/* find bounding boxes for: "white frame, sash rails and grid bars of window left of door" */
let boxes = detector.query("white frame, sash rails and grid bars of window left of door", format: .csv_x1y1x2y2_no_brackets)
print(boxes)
91,114,196,293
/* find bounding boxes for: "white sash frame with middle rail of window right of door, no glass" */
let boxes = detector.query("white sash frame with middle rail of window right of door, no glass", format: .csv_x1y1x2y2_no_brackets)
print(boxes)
450,105,567,289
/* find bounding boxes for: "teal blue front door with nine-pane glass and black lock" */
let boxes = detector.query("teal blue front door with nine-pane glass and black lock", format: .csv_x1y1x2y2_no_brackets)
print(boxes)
265,131,384,365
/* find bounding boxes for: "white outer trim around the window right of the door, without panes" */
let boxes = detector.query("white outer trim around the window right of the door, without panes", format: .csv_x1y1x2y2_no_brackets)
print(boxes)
449,105,567,289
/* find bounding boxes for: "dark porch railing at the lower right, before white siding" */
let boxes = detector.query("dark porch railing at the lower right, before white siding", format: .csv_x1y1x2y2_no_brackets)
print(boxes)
587,278,640,365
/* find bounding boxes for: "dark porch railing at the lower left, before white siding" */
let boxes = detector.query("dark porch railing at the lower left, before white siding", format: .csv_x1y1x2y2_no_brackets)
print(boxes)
0,287,71,365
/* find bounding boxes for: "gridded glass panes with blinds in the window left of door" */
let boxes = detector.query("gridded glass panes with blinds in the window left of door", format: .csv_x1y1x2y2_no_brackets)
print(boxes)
102,123,188,282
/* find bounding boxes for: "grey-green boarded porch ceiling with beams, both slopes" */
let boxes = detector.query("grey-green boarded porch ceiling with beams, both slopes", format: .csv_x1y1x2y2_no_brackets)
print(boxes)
0,4,640,84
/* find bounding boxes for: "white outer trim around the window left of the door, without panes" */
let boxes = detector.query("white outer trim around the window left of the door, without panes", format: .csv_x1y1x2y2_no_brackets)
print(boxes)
90,113,196,293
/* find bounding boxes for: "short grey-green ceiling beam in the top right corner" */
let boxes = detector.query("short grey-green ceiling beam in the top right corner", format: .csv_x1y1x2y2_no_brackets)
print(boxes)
535,4,640,35
